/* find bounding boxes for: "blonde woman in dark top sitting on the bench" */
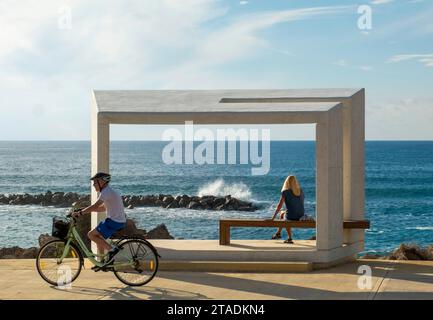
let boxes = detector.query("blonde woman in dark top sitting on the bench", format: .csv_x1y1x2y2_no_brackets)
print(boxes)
272,176,305,243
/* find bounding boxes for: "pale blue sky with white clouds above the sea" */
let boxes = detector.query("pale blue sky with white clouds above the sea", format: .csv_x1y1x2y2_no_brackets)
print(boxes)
0,0,433,140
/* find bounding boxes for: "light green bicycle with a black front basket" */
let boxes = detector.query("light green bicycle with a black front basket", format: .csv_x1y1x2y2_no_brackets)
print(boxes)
36,211,160,286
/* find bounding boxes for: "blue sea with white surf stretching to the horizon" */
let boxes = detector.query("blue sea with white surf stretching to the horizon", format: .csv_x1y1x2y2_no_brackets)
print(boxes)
0,141,433,254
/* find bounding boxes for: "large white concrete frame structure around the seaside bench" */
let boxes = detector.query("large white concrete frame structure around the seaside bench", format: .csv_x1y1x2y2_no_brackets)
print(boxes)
91,89,365,262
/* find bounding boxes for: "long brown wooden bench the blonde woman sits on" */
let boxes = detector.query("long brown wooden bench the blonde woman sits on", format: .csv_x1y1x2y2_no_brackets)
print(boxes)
220,219,370,245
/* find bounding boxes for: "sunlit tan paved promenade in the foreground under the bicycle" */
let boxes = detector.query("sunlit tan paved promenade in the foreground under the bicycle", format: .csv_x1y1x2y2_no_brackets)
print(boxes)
0,260,433,299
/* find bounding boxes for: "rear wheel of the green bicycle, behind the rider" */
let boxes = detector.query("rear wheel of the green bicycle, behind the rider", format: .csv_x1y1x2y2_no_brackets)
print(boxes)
113,239,158,286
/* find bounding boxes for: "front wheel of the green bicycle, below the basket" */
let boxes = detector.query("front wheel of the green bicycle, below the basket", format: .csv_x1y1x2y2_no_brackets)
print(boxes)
36,240,83,286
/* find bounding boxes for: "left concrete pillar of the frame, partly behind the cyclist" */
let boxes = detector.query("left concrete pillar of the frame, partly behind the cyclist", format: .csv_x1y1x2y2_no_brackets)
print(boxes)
90,94,110,253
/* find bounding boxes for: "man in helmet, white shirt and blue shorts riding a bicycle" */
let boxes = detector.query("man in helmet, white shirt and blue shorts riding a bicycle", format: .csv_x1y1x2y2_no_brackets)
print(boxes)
73,172,126,265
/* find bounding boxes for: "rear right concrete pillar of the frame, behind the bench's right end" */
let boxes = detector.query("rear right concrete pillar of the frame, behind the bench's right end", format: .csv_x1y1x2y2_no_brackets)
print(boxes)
344,89,365,243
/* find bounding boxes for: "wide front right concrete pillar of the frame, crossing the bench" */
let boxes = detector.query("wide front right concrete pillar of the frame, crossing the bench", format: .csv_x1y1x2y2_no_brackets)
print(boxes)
316,104,343,250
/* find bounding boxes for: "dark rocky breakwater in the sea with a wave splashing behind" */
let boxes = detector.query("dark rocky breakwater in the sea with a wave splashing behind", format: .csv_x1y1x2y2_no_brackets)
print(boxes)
0,191,258,211
